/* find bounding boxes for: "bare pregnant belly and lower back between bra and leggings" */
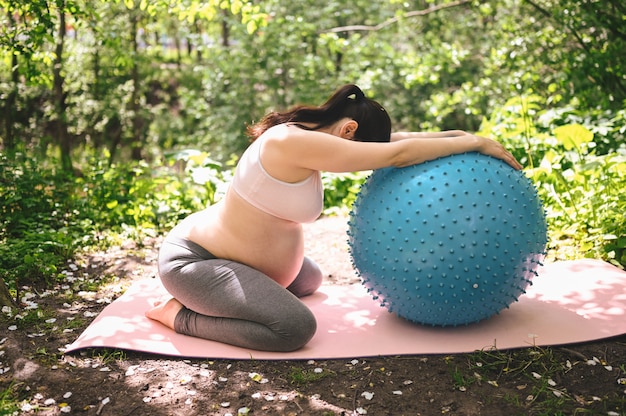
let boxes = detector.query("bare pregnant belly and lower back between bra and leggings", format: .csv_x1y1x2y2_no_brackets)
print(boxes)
165,191,304,287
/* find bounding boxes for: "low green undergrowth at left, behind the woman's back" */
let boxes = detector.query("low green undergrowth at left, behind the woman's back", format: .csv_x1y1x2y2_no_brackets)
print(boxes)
0,151,230,287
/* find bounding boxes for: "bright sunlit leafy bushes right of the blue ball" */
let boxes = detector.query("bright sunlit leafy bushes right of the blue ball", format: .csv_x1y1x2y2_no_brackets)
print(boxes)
482,96,626,266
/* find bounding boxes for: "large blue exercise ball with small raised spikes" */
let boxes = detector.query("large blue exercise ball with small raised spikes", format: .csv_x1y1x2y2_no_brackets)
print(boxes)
348,153,547,326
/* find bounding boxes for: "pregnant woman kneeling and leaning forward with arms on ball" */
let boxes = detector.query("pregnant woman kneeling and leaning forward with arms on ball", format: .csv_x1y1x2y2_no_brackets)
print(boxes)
146,85,521,351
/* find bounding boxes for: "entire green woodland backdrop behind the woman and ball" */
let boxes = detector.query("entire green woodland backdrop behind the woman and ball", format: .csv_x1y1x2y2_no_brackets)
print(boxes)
0,0,626,298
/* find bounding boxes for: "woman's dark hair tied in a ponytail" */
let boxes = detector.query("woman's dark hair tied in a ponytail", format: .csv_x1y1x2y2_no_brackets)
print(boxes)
247,84,391,142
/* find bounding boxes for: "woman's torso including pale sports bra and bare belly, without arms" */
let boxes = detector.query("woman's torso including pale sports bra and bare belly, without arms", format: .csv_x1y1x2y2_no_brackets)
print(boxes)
166,130,316,287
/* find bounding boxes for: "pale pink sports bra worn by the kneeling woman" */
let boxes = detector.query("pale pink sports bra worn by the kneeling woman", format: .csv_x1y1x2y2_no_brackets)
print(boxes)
231,139,324,223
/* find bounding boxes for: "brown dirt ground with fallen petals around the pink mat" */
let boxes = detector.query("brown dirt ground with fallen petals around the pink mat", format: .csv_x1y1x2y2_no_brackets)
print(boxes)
0,217,626,416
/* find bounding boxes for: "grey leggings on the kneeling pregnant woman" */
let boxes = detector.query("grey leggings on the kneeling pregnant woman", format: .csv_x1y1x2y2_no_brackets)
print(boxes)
159,236,322,351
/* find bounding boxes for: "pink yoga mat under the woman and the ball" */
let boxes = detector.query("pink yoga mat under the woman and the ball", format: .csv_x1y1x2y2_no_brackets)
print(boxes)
66,260,626,360
